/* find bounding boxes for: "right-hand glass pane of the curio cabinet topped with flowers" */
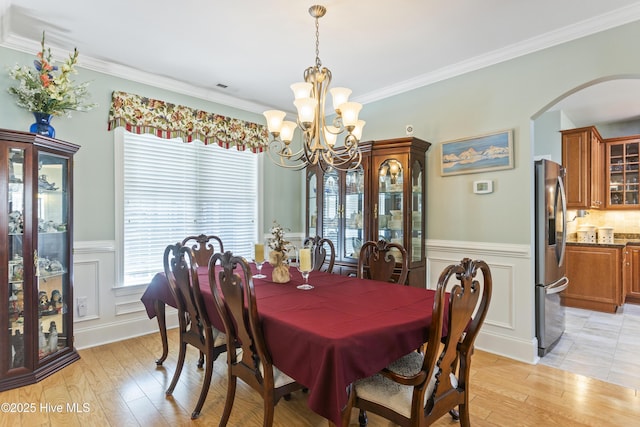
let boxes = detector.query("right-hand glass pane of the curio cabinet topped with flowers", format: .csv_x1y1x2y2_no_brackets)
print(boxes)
34,152,71,359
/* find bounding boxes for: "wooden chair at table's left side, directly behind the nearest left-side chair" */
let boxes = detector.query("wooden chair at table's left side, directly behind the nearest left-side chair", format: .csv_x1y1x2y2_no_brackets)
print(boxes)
164,243,227,419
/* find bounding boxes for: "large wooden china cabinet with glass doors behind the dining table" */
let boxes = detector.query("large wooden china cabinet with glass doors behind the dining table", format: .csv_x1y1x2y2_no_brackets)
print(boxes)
307,137,431,287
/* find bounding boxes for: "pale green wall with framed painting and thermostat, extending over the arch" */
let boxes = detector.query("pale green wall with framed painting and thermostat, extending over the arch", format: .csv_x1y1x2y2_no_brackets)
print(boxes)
361,22,640,244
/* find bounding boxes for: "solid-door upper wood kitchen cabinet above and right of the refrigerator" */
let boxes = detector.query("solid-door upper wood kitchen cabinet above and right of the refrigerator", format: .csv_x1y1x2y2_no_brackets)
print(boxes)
561,126,605,209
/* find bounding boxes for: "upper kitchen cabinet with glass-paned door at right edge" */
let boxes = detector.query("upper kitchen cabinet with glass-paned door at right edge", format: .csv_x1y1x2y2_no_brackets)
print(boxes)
605,135,640,209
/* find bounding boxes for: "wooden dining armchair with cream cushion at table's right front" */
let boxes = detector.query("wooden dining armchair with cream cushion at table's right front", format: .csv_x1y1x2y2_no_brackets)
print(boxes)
343,258,492,427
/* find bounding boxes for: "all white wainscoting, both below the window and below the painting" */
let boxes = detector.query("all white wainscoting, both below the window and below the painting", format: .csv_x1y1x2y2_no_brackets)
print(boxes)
74,240,538,363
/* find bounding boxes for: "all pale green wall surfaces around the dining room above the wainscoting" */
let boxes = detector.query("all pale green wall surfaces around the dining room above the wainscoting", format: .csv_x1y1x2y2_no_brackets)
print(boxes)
0,19,640,244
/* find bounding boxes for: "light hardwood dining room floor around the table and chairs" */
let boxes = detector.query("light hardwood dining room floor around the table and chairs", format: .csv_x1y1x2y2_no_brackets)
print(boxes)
0,330,640,427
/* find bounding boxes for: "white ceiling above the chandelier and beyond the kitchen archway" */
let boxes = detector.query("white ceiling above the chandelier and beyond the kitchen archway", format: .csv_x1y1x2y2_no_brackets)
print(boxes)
0,0,640,126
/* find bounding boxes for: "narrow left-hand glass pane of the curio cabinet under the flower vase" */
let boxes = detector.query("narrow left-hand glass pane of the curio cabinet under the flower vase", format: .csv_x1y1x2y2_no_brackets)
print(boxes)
6,148,25,368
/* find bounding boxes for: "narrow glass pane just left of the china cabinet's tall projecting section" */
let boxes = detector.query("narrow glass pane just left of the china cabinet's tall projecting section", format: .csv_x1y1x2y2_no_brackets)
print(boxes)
341,166,364,258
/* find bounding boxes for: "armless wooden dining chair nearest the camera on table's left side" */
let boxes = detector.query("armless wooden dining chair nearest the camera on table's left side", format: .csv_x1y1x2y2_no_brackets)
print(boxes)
209,252,303,427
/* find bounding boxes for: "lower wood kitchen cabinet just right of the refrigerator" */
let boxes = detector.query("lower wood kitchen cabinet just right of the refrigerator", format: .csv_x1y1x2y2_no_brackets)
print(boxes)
561,245,624,313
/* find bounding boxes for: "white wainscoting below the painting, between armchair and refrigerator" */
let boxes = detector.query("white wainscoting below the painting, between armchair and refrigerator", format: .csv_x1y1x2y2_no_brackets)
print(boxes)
427,240,537,363
